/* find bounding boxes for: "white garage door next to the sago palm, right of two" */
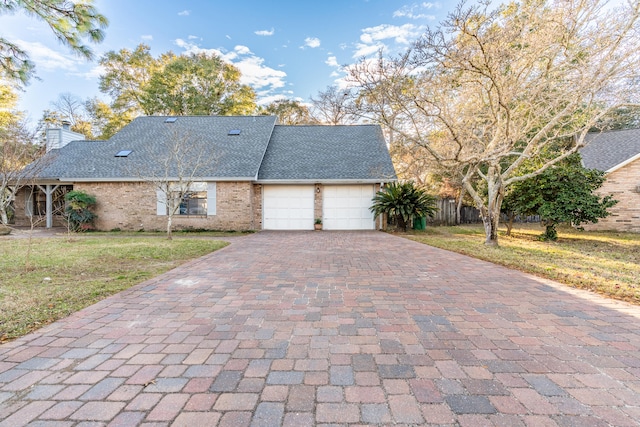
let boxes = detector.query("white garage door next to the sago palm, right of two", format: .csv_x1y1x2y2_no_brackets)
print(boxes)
322,185,375,230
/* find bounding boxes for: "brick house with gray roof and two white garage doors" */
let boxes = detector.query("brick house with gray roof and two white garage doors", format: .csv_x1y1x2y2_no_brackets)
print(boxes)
16,116,396,230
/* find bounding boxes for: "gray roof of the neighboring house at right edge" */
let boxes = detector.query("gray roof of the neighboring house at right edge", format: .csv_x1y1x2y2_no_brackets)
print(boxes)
580,129,640,172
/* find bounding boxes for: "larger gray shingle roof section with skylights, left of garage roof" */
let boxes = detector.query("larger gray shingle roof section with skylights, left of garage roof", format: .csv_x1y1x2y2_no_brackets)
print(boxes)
38,116,276,181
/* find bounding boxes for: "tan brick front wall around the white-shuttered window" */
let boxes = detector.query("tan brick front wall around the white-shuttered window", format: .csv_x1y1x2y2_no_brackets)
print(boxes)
74,182,254,231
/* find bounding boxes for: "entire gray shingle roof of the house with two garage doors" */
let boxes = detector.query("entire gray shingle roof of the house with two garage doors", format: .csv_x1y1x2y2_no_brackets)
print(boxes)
37,116,396,182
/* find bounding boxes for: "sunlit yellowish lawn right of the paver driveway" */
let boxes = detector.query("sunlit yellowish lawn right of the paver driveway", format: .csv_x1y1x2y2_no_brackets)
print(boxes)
404,224,640,305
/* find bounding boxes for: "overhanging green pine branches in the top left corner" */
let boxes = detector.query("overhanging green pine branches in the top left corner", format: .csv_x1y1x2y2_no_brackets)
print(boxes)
0,0,108,84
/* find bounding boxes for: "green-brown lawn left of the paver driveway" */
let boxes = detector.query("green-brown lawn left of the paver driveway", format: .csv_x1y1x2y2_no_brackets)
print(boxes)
0,233,227,342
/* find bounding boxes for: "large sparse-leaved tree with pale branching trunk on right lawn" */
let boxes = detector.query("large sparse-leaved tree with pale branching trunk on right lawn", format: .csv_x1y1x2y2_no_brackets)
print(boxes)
350,0,640,245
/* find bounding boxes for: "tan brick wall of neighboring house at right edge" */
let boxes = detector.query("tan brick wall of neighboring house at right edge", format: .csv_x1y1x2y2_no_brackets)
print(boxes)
584,159,640,233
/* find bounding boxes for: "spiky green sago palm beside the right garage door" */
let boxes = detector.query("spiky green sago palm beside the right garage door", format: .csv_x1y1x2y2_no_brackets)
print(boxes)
370,181,436,231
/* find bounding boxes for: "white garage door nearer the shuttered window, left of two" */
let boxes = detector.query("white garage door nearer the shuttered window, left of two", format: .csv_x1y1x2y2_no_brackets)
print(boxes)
262,185,314,230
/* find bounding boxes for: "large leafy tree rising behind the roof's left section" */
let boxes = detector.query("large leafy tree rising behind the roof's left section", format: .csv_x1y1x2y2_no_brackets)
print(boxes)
140,53,256,116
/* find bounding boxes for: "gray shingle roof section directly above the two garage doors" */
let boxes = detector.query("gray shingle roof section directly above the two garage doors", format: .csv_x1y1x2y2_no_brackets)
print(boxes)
258,125,396,181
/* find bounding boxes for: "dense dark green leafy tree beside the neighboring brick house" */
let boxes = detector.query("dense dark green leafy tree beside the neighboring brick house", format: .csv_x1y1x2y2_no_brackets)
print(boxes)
505,154,618,240
